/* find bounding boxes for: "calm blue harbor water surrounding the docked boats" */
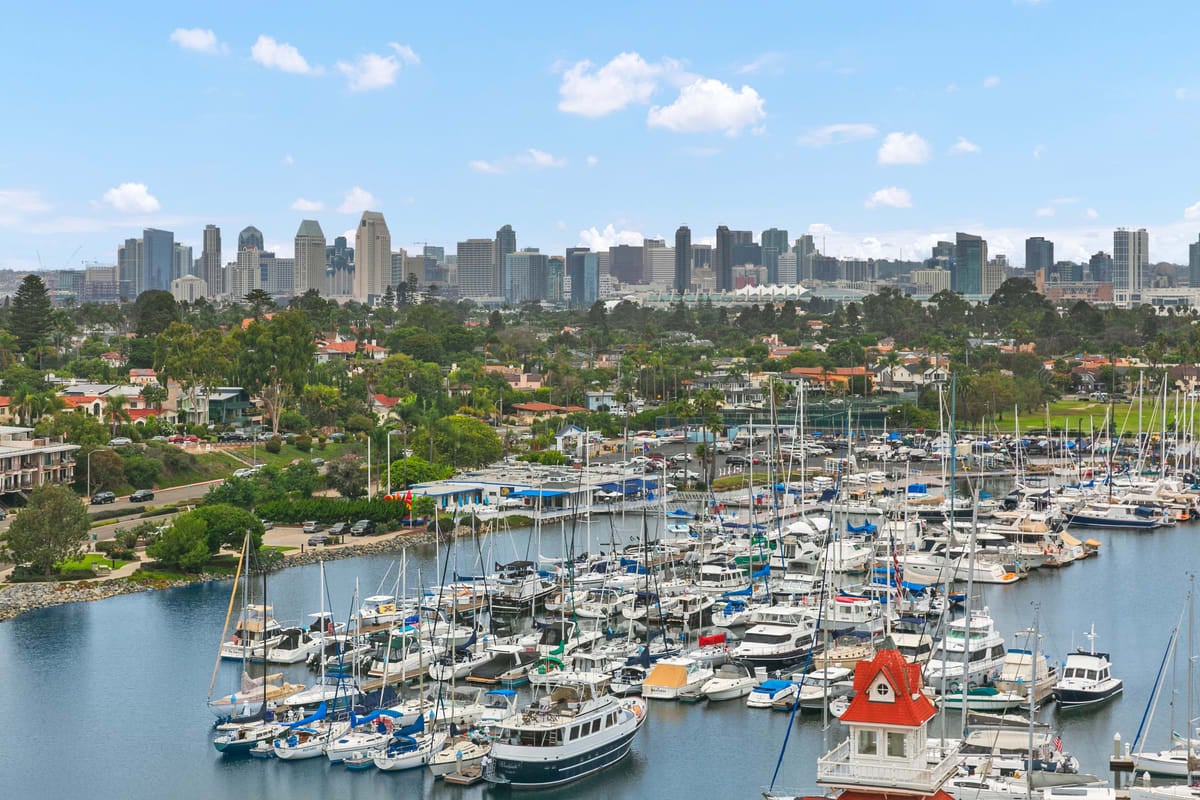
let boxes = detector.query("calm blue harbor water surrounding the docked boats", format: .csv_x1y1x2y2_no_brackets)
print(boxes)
0,513,1200,800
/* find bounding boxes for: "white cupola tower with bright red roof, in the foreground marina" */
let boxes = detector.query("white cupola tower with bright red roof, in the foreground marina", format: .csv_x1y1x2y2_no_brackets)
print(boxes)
817,642,958,800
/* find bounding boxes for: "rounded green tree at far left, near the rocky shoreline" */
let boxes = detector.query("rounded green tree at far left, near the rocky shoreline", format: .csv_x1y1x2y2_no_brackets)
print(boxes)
6,483,89,576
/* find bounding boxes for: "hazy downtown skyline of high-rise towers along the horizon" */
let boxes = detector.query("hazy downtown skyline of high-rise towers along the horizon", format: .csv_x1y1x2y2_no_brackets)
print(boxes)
25,211,1200,307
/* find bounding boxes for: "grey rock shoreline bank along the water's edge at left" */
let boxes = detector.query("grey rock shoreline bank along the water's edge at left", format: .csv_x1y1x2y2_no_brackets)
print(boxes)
0,528,470,622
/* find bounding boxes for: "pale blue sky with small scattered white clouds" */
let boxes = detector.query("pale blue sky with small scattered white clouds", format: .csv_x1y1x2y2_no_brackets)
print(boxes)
0,0,1200,269
